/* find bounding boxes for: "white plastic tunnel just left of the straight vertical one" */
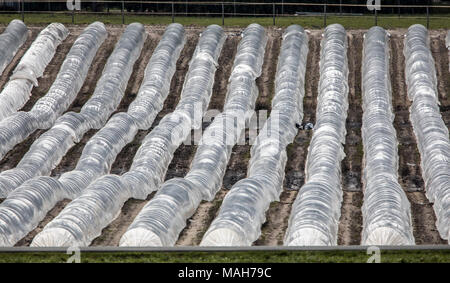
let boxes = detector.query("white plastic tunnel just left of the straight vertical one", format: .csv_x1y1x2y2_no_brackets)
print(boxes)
284,24,348,246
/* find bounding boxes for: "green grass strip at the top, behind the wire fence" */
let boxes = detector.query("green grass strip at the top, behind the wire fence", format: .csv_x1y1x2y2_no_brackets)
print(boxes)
0,13,450,29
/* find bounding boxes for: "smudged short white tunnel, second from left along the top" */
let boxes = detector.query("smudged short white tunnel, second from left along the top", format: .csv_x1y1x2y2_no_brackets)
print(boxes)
0,23,69,121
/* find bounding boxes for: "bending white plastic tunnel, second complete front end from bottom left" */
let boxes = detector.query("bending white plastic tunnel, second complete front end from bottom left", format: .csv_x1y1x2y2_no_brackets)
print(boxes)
120,24,267,246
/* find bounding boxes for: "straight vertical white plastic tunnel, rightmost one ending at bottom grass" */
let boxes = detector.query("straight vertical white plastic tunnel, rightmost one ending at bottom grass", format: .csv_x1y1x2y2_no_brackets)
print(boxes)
361,27,414,245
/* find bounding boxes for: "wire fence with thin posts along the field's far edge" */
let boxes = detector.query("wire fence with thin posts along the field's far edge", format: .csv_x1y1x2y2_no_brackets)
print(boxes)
0,0,450,28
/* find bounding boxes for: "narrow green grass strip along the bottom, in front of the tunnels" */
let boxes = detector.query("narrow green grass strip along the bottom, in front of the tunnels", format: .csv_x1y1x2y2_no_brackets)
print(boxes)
0,250,450,263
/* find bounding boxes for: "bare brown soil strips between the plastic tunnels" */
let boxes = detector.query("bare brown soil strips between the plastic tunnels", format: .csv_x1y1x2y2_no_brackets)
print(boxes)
0,25,450,246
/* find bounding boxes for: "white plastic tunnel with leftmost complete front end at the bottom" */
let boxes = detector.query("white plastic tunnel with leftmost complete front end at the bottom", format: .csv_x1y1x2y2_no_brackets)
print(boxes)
29,25,225,246
